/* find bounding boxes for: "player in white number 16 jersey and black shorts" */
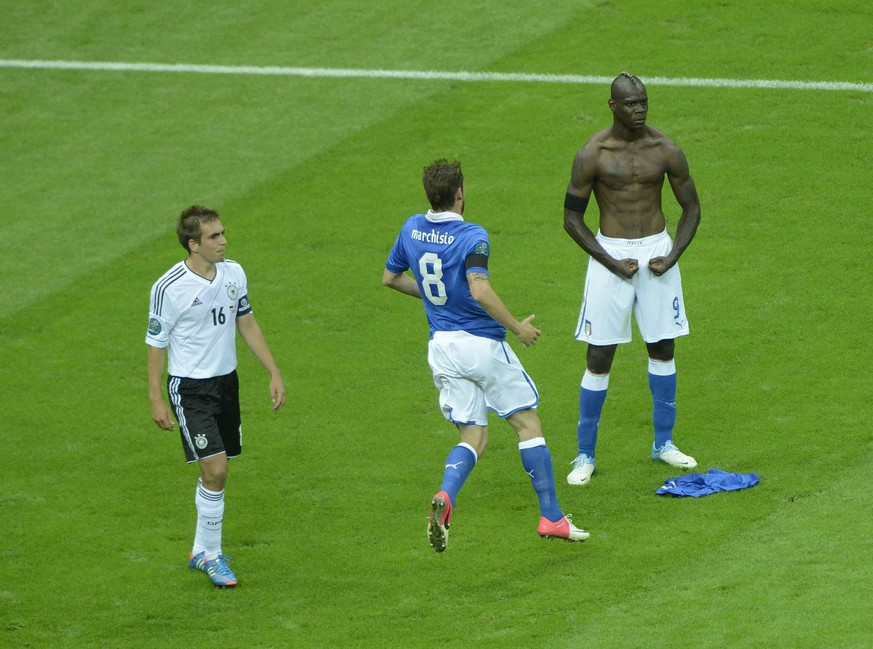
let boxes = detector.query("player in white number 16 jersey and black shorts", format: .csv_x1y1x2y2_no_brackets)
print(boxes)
146,205,285,587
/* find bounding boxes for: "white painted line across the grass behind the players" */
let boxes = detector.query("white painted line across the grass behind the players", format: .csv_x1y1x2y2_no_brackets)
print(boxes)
0,59,873,92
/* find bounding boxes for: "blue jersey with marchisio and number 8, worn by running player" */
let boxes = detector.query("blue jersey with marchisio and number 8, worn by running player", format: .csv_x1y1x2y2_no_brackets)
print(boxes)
385,211,506,340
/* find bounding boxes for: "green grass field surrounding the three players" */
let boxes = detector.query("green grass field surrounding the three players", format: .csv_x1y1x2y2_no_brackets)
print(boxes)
0,0,873,649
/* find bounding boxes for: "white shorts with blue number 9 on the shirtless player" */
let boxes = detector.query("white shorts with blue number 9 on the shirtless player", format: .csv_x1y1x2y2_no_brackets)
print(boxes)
576,230,688,345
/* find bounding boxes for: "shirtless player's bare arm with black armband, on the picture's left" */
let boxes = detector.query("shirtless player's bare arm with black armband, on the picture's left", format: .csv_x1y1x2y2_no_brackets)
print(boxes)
564,145,639,279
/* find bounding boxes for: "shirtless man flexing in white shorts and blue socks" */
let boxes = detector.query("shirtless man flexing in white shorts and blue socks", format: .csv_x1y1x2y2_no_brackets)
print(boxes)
564,72,700,485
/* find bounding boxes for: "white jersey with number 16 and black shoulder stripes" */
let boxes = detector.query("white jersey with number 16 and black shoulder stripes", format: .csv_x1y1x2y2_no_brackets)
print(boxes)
146,260,252,379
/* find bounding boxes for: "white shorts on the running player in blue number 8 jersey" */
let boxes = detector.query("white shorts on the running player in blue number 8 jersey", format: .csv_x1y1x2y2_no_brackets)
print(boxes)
427,331,540,426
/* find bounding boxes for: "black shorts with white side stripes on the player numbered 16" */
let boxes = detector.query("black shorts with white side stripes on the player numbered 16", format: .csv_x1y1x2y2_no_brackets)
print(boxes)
167,371,242,464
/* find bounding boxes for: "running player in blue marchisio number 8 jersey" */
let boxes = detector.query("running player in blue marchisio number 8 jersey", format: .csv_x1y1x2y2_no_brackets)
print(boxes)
382,160,588,552
